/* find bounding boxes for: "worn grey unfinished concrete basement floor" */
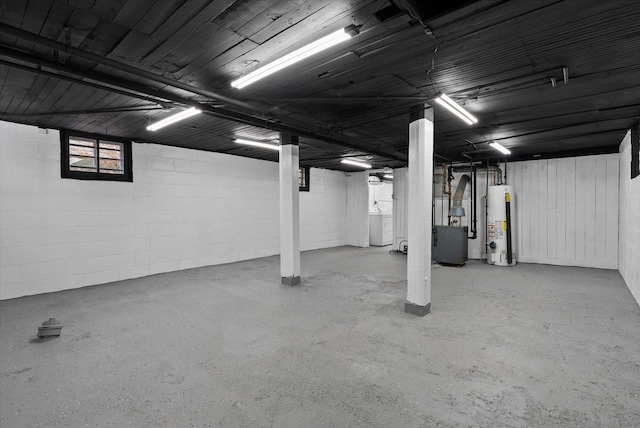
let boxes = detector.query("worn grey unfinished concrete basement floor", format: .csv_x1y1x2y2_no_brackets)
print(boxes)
0,247,640,428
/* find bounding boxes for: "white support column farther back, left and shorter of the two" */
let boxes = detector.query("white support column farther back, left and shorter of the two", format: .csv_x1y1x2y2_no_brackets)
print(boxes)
280,133,300,285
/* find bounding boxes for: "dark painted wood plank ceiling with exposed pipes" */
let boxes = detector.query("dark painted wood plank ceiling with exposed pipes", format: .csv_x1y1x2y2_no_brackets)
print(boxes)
0,0,640,169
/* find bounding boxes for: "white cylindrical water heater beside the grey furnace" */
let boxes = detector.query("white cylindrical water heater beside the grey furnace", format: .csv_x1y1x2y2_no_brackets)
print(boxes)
487,184,516,266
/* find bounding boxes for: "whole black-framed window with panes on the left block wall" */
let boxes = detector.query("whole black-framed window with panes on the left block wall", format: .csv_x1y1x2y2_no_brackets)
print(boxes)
60,130,133,181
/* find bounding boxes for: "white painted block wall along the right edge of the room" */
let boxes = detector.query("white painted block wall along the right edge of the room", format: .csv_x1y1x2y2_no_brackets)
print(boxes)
618,131,640,304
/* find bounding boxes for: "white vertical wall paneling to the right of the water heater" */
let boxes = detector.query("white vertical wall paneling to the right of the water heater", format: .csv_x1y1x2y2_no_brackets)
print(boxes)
507,154,618,269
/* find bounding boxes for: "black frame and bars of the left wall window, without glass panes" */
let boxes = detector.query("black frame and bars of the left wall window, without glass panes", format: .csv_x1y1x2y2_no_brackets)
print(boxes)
60,129,133,182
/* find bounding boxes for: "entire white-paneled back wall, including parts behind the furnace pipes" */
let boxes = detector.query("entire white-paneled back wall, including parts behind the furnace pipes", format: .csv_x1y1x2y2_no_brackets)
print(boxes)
394,154,623,269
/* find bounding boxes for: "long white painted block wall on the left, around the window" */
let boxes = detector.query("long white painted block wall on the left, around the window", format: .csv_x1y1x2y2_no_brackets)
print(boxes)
0,121,347,299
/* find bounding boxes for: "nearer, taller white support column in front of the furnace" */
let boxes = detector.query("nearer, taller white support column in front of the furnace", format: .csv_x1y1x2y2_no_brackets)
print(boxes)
404,106,433,316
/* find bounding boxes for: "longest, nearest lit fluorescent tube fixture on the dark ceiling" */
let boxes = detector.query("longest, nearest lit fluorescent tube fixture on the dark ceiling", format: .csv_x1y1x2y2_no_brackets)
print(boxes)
231,25,358,89
